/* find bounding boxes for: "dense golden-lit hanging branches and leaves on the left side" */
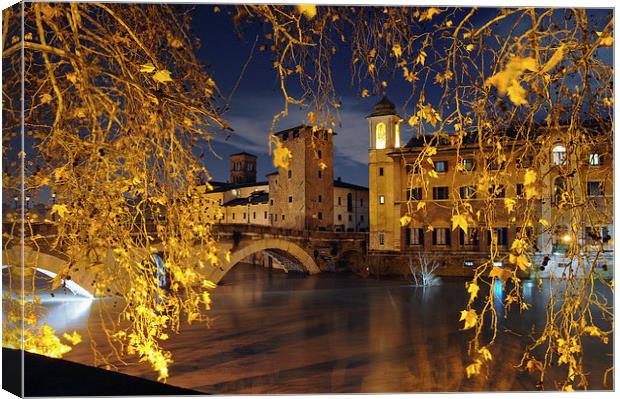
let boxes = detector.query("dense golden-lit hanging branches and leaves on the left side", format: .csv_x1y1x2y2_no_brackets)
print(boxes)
3,3,228,380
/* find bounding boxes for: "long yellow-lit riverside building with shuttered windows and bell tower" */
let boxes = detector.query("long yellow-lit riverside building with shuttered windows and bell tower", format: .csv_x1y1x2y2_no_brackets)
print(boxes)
368,97,614,275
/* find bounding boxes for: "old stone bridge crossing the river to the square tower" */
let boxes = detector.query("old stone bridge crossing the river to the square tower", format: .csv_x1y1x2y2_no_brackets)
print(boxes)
2,223,368,293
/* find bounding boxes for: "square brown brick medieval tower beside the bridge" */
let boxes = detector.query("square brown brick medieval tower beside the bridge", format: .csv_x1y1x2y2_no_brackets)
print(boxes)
269,125,335,230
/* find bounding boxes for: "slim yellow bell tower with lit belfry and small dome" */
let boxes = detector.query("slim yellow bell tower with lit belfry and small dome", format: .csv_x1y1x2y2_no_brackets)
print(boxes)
366,95,402,251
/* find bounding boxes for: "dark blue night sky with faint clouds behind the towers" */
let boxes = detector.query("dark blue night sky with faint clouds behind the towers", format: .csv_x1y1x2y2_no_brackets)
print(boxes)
191,4,612,185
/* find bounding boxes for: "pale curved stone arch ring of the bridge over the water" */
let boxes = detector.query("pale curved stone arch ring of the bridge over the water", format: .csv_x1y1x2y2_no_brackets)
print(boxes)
211,238,321,283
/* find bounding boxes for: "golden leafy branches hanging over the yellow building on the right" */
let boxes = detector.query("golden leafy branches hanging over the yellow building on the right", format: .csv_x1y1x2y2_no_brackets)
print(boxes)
235,5,613,390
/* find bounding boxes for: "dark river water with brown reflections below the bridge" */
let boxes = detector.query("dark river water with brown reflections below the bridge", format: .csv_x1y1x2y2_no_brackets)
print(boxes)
27,265,613,394
